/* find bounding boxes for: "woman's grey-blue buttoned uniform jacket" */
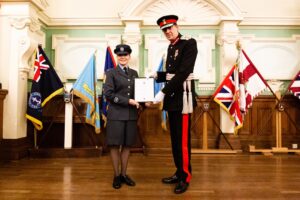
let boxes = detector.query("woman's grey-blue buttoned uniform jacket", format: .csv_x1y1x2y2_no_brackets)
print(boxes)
103,65,138,120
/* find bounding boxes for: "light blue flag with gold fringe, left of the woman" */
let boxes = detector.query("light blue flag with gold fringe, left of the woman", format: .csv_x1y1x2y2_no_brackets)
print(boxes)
73,54,101,133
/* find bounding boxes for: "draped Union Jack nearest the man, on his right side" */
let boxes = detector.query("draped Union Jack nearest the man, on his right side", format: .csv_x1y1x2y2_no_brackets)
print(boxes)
213,65,243,133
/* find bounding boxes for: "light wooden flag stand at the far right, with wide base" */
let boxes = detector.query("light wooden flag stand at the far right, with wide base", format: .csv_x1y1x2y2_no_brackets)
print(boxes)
249,91,300,155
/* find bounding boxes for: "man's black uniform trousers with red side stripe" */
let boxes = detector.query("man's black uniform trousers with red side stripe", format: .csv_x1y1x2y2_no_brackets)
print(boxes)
168,111,192,183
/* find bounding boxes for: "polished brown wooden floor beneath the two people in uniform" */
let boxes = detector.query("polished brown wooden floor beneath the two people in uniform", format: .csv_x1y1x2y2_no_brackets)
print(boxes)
0,153,300,200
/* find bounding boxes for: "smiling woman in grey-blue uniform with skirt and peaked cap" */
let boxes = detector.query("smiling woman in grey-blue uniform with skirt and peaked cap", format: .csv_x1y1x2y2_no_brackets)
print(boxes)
103,44,140,189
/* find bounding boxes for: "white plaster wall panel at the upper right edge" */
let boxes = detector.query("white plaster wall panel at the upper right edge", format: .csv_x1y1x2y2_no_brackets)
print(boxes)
243,35,300,80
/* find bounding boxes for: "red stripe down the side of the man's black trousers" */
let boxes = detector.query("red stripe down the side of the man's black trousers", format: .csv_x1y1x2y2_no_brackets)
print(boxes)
182,114,192,183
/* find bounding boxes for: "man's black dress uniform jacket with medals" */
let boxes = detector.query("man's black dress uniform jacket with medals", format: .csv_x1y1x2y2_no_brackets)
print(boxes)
156,35,198,111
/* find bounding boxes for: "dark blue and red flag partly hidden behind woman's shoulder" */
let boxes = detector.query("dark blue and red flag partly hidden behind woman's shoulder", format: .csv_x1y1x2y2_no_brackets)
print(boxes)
101,46,116,126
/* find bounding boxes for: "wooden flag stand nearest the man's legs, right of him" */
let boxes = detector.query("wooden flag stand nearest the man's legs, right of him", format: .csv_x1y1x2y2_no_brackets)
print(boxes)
191,98,240,154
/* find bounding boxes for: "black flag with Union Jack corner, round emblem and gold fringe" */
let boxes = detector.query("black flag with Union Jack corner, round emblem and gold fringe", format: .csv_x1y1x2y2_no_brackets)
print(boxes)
25,45,64,130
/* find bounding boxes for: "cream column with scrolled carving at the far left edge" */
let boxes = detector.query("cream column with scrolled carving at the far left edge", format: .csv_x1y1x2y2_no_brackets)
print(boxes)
0,1,45,139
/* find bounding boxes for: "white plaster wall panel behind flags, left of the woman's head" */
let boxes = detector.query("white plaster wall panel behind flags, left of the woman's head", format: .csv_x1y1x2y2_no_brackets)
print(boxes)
52,35,121,80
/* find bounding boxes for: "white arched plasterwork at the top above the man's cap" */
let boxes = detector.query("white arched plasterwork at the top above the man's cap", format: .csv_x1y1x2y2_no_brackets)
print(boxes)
119,0,242,25
